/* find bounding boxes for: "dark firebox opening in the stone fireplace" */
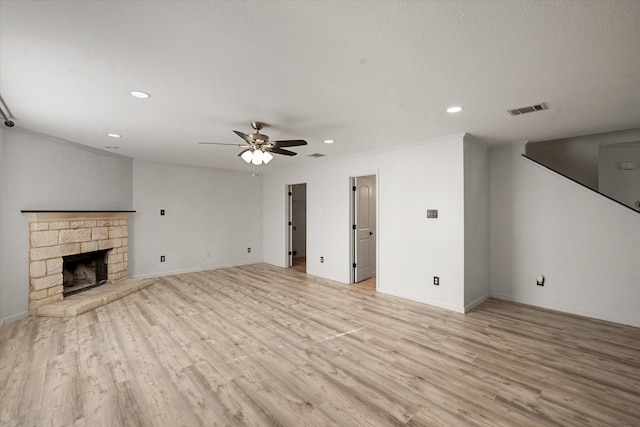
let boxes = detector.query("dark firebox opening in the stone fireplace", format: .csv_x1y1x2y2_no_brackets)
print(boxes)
62,250,108,296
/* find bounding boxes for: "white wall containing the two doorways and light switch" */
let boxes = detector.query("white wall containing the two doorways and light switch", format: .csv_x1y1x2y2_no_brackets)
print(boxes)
263,135,464,312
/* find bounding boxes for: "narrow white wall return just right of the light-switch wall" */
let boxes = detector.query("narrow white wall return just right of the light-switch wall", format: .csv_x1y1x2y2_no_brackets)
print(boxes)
464,135,490,311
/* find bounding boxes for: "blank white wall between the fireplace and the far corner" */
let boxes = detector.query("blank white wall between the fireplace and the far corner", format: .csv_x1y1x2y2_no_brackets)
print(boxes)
129,160,262,277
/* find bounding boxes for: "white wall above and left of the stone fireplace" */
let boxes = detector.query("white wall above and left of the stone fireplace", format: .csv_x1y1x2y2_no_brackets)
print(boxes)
0,128,133,321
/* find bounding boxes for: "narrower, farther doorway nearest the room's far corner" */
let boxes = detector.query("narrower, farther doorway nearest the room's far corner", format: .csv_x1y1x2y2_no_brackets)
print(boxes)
287,183,307,273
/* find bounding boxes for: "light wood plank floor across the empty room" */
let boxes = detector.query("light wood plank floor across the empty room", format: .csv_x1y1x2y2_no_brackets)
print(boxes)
0,264,640,426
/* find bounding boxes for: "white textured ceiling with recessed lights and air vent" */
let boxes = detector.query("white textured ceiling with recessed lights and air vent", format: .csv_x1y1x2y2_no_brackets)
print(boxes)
0,0,640,170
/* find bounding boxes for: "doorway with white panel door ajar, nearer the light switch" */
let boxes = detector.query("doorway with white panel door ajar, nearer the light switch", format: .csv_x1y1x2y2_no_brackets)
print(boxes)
350,175,377,289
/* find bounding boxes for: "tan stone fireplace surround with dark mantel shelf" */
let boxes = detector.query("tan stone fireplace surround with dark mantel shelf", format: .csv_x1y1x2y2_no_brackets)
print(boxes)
23,211,129,314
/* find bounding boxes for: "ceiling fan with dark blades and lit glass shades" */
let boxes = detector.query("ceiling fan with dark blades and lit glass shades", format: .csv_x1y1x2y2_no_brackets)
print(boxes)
198,122,307,165
